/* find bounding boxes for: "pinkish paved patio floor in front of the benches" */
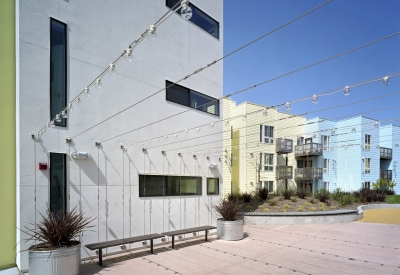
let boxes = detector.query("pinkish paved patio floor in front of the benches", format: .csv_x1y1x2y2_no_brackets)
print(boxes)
82,222,400,275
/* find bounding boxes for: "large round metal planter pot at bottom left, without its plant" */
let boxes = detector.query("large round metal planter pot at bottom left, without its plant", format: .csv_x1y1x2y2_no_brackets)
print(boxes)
29,244,81,275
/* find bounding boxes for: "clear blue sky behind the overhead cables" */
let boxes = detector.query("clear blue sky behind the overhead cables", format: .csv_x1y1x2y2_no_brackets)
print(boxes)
223,0,400,125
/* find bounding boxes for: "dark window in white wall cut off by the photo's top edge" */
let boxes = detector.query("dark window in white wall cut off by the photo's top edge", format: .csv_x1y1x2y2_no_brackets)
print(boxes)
166,0,219,38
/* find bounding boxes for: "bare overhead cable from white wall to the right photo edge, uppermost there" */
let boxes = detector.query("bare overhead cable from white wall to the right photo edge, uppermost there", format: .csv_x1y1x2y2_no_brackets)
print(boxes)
99,32,400,142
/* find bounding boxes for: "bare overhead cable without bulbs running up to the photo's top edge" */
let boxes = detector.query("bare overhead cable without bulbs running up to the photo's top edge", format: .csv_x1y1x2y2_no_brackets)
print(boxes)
72,0,333,138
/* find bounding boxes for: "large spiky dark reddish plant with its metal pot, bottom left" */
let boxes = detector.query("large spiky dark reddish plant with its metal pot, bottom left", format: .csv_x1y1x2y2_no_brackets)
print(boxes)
21,207,94,275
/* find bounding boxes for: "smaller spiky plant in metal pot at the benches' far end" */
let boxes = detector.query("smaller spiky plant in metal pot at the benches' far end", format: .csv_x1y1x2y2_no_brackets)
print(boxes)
214,200,243,241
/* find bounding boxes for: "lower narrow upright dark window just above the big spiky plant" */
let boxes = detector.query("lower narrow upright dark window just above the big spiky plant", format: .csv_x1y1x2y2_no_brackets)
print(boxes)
50,153,67,214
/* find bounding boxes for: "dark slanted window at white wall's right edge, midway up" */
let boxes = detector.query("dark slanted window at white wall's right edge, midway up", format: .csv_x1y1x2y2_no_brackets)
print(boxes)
166,80,219,116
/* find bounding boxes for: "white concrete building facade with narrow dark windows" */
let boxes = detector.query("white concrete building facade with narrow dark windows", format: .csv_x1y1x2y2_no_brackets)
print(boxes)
16,0,223,270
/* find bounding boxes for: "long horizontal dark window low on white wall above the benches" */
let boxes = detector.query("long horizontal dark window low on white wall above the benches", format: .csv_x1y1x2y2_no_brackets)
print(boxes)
139,175,202,197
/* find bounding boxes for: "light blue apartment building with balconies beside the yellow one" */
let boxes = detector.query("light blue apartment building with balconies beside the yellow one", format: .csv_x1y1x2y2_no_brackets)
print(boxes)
295,116,400,194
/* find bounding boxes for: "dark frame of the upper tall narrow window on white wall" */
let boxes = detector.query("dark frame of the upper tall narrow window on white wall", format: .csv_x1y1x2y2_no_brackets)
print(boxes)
49,17,68,127
